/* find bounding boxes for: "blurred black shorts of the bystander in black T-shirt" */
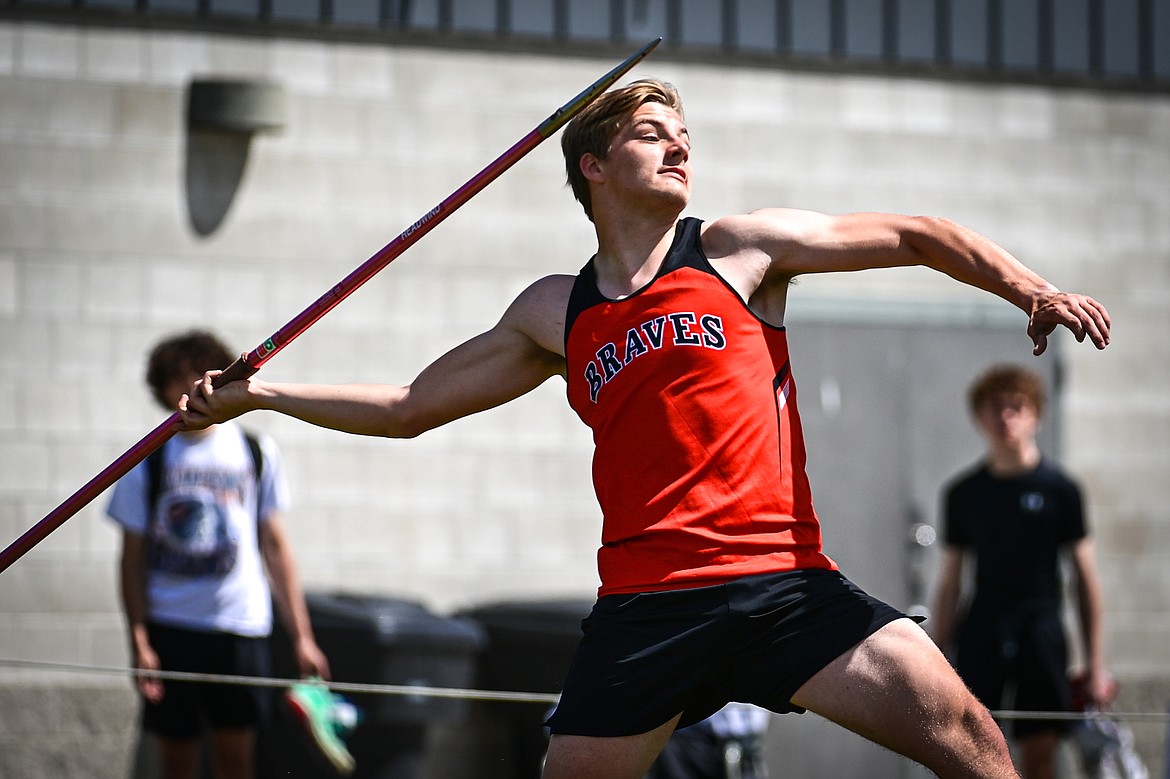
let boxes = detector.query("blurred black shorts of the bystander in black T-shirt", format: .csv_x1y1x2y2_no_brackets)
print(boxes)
955,607,1073,737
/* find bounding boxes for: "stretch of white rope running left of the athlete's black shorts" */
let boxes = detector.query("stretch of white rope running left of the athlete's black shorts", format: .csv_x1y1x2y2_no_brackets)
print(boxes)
0,659,560,703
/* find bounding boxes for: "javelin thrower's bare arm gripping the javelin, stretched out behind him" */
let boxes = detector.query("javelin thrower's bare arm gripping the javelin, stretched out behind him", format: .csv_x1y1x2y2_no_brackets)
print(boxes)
179,279,564,437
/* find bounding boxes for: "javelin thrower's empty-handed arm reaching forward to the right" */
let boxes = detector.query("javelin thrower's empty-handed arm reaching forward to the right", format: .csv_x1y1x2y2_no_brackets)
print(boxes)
703,208,1110,354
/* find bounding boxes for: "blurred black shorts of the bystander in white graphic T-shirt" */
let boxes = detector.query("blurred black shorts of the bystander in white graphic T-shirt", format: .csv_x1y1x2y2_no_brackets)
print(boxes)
143,623,273,739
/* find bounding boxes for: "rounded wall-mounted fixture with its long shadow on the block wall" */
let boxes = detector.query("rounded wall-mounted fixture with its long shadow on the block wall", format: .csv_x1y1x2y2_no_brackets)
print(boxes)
185,78,288,236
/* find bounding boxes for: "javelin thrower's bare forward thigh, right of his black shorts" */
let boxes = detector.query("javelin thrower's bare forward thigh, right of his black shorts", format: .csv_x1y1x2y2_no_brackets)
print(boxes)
792,619,977,753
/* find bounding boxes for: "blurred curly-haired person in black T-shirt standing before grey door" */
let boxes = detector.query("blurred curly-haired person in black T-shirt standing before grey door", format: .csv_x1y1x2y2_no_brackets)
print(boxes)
932,365,1113,779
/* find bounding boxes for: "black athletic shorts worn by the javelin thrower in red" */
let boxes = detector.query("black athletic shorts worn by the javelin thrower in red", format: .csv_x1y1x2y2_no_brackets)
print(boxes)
548,570,904,736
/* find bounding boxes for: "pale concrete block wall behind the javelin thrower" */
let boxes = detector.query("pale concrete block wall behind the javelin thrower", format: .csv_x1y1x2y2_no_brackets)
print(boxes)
0,16,1170,776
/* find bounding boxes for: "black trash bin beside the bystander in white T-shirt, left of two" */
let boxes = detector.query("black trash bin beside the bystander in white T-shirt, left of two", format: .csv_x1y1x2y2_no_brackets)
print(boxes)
264,593,486,779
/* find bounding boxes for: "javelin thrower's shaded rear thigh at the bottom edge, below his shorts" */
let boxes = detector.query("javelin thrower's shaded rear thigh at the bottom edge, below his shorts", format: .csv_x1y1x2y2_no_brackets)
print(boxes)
541,717,679,779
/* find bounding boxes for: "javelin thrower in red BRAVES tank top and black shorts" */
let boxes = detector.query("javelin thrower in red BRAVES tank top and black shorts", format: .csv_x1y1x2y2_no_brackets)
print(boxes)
180,82,1109,779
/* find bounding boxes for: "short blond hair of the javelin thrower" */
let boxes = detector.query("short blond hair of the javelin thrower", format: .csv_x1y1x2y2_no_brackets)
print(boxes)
560,78,682,221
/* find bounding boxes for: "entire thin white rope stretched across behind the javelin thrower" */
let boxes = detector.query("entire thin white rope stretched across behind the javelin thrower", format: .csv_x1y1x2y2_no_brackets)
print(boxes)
0,659,1170,723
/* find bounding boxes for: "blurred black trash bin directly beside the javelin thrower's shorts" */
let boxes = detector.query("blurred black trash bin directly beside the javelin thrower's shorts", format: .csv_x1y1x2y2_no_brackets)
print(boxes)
442,598,593,779
